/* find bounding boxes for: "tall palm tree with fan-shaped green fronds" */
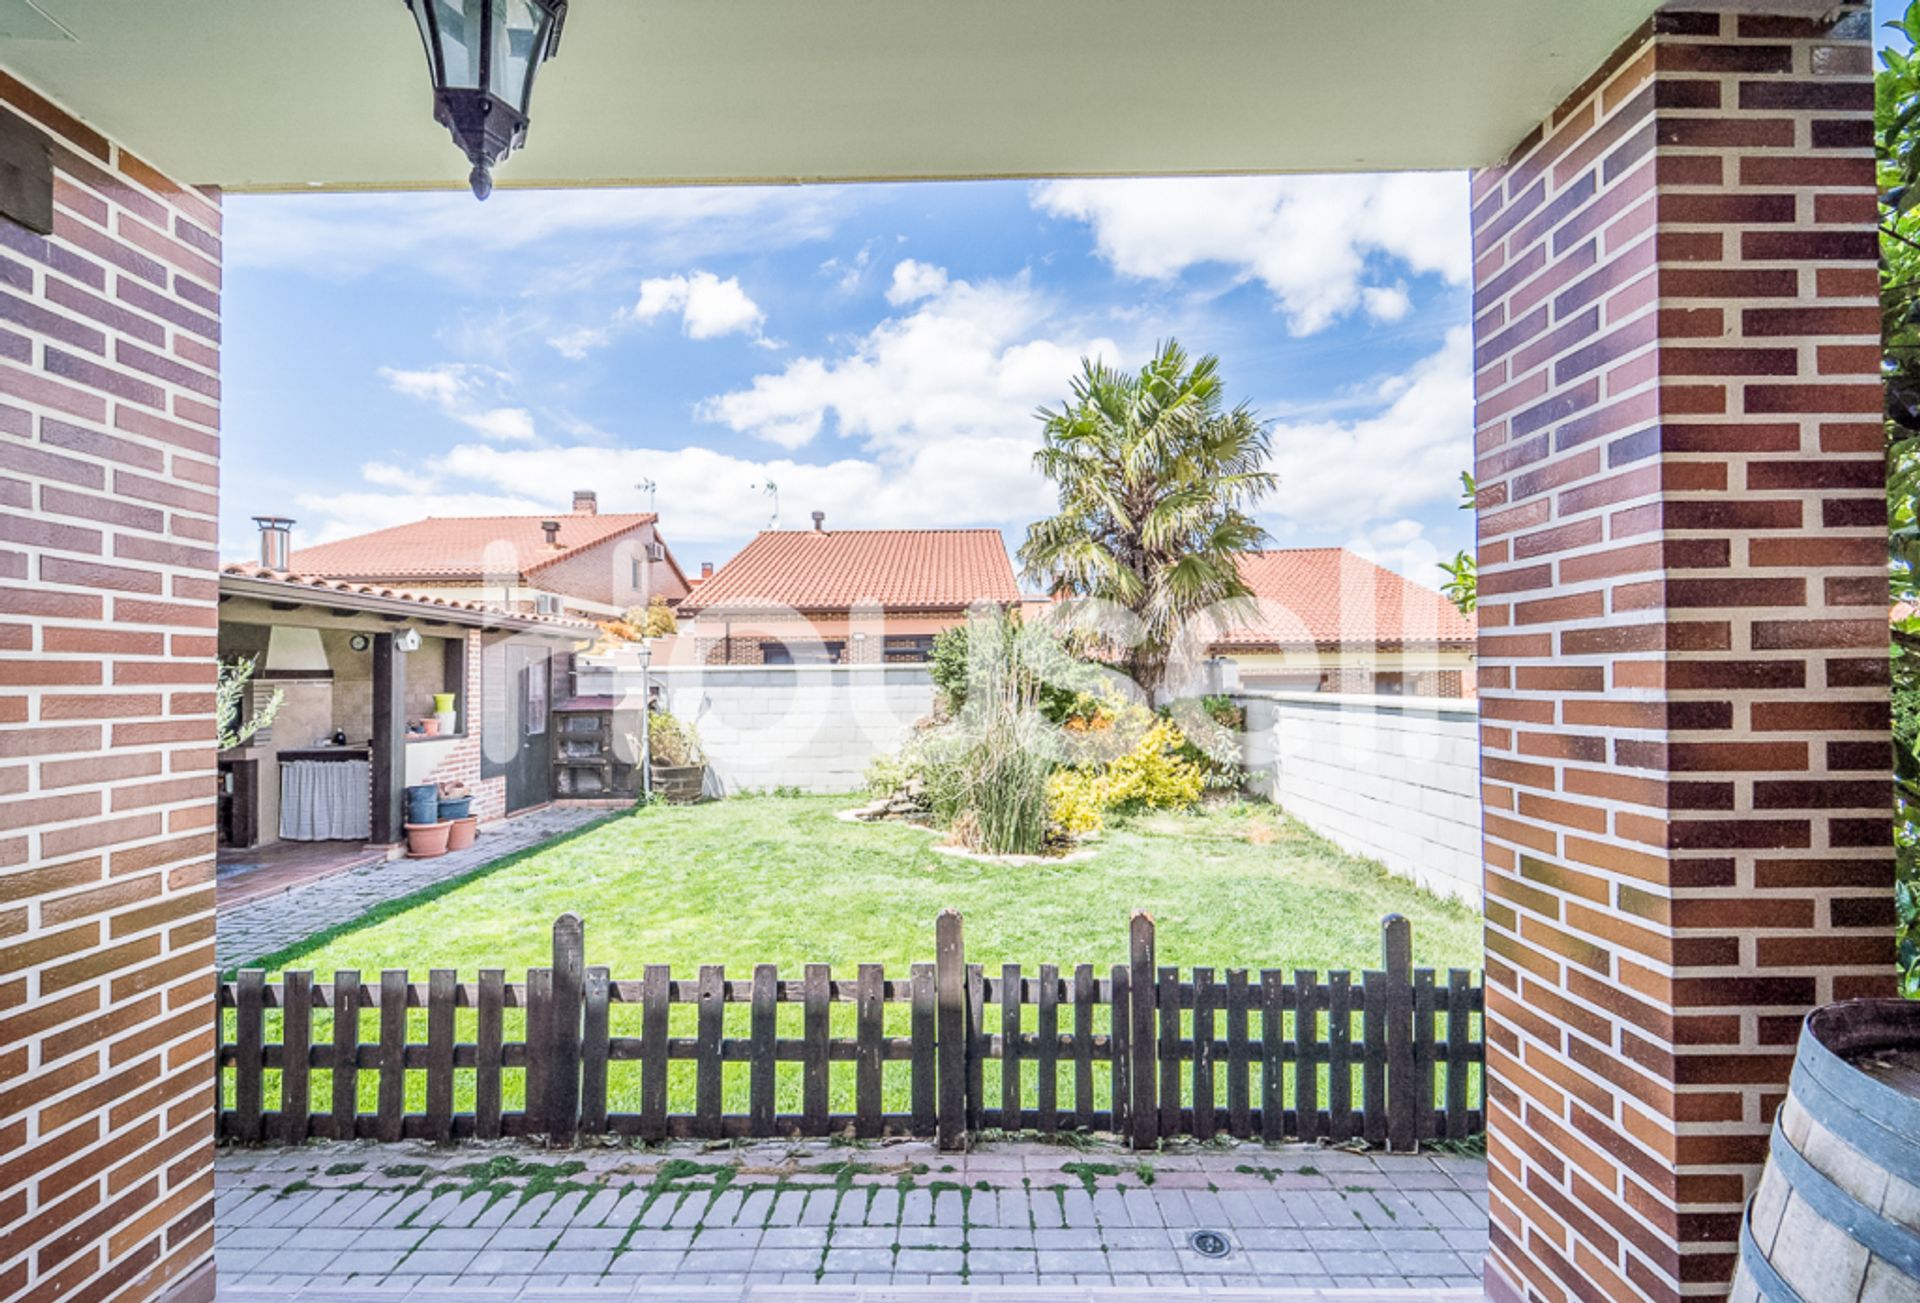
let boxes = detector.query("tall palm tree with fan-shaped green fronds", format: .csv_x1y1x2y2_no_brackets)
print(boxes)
1020,340,1277,695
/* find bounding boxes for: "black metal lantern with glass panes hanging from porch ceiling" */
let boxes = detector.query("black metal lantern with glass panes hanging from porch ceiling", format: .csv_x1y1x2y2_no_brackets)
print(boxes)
405,0,566,200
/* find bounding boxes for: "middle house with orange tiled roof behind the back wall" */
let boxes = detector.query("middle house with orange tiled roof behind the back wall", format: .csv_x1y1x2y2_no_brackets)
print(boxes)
668,512,1020,666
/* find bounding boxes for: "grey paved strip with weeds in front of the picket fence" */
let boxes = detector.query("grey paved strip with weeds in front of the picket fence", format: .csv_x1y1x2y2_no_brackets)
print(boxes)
217,1142,1486,1303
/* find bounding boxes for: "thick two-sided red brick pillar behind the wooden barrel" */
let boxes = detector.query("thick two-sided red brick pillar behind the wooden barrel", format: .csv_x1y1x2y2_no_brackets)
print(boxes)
1473,6,1893,1301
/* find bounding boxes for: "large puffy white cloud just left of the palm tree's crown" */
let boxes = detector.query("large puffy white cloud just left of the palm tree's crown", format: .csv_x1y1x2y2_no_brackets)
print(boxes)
697,276,1125,459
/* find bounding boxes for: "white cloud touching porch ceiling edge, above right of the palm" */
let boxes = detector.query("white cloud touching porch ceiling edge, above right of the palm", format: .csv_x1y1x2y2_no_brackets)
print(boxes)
1033,173,1473,336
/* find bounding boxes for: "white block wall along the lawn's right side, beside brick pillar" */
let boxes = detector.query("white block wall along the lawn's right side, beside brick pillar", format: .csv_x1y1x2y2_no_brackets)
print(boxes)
1235,689,1480,908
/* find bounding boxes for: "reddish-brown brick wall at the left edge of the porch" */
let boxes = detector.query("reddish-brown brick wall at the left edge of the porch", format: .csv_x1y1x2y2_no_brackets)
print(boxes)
0,75,221,1299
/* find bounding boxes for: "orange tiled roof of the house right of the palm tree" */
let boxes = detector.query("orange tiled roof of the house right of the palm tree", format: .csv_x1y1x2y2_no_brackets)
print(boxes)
1213,547,1475,651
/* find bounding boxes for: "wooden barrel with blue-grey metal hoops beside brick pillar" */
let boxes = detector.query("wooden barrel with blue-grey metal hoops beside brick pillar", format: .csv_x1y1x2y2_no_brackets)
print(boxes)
1732,1000,1920,1303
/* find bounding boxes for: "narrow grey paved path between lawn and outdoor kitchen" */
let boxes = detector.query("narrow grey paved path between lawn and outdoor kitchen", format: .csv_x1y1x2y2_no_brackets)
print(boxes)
213,810,609,969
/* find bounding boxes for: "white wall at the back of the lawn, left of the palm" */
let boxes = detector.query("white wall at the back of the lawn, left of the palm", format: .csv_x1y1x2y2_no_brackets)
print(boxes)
576,658,933,796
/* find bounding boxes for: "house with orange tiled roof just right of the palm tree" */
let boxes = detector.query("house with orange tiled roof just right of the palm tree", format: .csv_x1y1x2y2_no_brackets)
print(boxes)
1208,547,1476,697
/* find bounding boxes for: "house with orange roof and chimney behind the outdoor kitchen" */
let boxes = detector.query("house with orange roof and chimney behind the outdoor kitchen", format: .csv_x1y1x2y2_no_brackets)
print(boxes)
284,489,689,620
